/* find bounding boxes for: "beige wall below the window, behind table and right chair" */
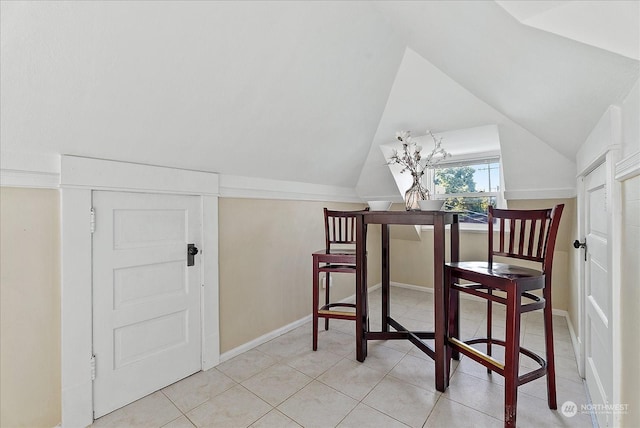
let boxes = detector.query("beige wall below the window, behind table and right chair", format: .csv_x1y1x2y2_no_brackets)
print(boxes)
390,198,575,310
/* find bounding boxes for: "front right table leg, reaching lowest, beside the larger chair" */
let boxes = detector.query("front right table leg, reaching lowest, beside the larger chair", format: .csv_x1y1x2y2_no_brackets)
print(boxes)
433,216,447,392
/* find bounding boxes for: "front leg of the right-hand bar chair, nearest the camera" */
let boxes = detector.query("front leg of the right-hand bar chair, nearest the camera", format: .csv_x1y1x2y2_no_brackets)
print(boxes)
504,283,521,428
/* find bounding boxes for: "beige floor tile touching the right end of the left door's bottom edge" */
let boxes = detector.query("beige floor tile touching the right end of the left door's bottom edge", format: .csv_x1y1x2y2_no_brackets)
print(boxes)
162,368,236,413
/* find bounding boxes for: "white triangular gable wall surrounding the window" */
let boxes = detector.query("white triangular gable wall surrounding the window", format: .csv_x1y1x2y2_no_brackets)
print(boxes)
357,49,576,200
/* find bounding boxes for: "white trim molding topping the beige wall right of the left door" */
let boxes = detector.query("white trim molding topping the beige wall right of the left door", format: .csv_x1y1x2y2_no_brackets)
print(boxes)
220,174,363,203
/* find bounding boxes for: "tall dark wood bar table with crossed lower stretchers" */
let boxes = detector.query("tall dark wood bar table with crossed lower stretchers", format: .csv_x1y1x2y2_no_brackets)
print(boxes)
356,211,460,391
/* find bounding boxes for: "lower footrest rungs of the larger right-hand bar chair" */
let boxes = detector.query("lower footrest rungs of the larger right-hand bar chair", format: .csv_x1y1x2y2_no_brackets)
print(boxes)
449,337,547,385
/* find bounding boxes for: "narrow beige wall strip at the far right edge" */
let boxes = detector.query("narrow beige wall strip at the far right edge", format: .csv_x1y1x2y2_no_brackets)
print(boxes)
620,176,640,427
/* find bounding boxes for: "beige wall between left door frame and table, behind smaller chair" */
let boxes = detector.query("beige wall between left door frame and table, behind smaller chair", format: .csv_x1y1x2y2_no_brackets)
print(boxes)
219,198,380,352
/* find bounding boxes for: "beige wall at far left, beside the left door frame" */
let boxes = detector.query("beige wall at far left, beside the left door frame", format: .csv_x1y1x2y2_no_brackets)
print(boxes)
0,187,61,428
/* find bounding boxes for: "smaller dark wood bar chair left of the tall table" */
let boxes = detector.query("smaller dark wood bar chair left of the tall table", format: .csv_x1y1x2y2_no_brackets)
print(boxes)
313,208,368,351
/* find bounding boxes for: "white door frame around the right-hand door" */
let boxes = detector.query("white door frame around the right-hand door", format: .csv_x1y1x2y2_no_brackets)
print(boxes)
574,106,622,426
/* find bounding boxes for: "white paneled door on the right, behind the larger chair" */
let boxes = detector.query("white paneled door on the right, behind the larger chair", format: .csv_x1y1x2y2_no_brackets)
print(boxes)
583,164,613,427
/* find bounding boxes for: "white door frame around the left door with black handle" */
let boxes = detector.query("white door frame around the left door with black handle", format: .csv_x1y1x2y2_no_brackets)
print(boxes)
60,155,220,427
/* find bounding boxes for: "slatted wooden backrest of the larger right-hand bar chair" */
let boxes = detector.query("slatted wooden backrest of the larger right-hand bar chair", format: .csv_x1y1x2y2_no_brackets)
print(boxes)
488,204,564,270
